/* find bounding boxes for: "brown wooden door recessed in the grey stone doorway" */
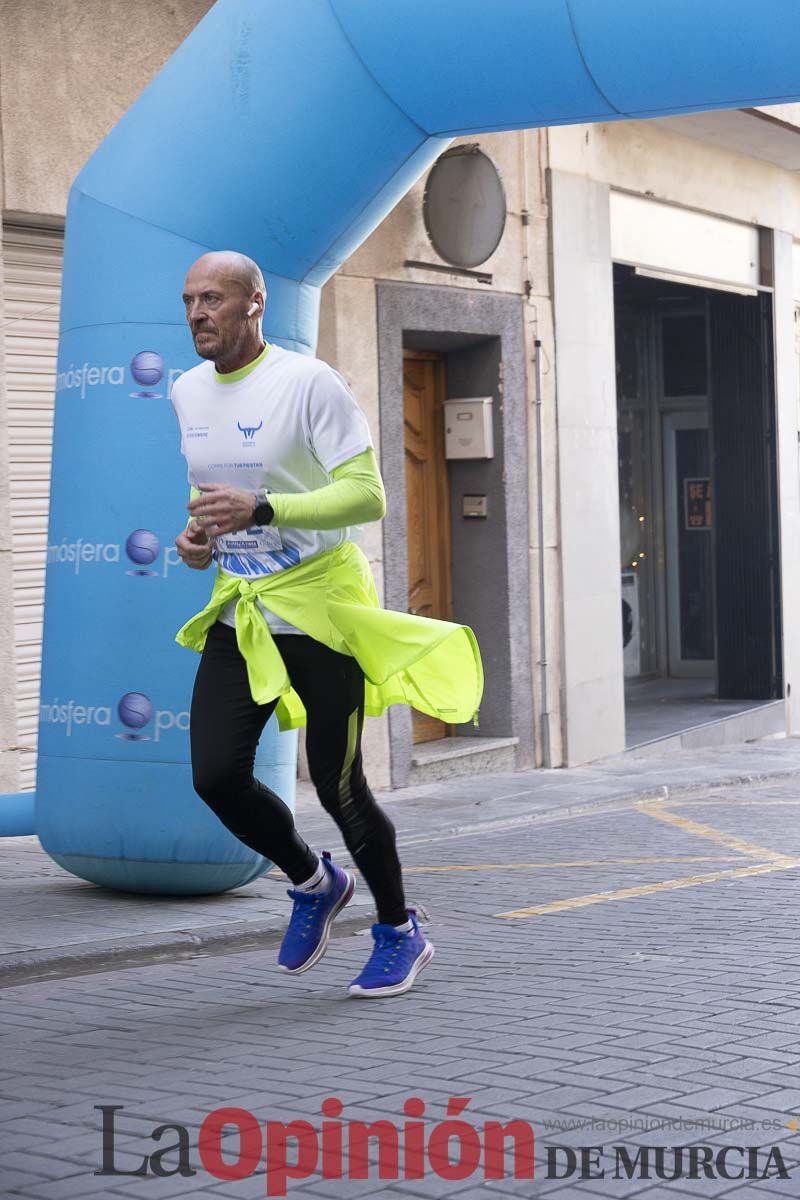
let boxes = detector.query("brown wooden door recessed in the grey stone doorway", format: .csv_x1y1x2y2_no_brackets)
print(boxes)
403,350,455,743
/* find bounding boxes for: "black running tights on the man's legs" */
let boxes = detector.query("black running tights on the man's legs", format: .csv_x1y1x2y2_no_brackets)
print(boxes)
190,622,408,925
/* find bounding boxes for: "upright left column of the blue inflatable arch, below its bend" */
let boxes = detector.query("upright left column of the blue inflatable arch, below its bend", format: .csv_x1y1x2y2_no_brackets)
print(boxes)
36,194,309,893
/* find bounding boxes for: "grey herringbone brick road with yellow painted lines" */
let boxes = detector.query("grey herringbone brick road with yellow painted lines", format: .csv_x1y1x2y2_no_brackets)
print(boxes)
0,780,800,1200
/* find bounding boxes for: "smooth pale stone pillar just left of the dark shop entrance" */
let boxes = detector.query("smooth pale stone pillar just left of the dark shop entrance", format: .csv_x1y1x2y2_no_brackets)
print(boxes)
551,170,625,767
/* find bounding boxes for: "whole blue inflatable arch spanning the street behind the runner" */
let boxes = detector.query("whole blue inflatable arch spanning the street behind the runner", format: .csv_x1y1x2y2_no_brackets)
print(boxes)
0,0,800,893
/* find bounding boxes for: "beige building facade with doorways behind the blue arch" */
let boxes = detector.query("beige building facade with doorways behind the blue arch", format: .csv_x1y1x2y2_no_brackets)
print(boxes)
0,7,800,791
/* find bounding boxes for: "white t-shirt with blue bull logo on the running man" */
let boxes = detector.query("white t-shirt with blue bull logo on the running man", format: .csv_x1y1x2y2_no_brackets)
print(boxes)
170,346,373,634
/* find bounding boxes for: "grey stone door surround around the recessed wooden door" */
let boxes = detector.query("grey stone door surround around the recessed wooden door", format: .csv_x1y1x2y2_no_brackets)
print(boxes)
375,280,536,787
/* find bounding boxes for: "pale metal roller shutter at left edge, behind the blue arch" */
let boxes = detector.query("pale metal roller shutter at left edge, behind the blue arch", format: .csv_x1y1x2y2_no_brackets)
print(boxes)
2,224,64,791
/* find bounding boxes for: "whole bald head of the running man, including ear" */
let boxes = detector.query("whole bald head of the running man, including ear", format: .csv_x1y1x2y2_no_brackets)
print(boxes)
184,250,266,373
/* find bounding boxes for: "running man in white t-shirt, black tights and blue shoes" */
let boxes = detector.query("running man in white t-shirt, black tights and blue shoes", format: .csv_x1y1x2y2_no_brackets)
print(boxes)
172,251,482,997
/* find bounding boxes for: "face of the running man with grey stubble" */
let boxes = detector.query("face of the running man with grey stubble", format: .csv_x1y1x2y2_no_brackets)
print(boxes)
184,263,252,360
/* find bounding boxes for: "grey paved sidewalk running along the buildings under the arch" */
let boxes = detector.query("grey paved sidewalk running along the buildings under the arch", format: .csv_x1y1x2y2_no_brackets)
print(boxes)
0,738,800,985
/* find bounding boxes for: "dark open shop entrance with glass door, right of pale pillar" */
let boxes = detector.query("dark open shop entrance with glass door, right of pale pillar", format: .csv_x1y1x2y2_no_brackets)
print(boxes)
614,266,782,745
